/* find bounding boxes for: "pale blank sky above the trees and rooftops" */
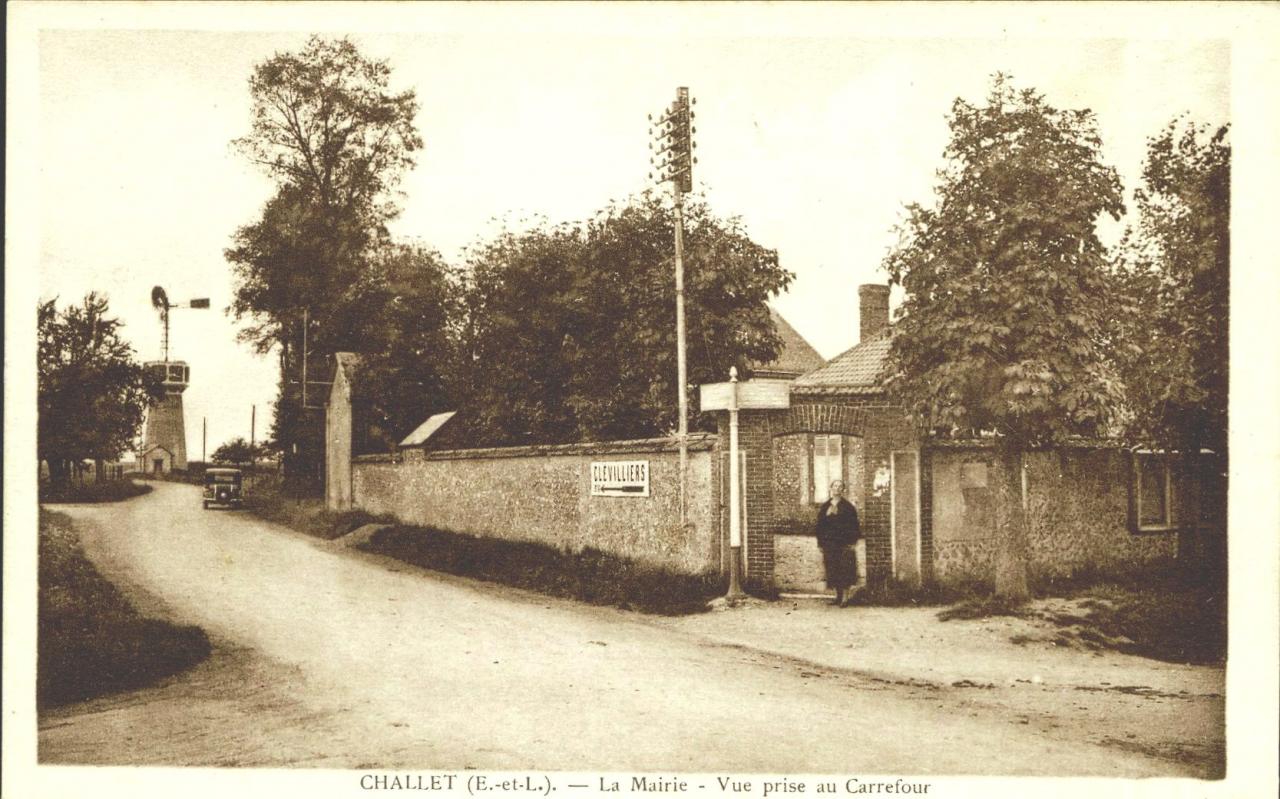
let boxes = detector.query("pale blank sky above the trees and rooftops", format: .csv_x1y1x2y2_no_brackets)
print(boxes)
35,9,1231,458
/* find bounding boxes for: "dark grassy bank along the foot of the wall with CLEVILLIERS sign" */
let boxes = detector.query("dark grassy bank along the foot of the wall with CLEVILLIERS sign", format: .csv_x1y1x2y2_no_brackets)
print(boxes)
360,525,724,616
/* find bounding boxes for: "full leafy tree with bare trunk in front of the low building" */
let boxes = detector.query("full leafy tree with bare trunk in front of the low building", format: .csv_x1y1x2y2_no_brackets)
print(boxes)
884,76,1124,598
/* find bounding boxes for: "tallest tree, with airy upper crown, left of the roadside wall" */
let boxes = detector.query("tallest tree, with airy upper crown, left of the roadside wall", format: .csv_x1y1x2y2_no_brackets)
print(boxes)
225,36,422,484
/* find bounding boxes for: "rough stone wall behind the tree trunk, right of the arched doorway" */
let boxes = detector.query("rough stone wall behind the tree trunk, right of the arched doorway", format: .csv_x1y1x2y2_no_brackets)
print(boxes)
928,447,1178,581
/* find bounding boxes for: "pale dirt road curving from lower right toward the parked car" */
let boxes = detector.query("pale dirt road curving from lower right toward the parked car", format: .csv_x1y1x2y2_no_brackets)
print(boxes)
40,484,1196,776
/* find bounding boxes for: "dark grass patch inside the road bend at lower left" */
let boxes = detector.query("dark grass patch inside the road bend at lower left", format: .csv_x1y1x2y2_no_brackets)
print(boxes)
36,508,210,708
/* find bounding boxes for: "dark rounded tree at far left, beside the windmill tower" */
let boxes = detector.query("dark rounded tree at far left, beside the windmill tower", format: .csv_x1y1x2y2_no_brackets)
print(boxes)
36,292,164,484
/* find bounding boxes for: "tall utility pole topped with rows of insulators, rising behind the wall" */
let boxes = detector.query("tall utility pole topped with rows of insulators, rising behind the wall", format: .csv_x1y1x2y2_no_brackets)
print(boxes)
649,86,698,525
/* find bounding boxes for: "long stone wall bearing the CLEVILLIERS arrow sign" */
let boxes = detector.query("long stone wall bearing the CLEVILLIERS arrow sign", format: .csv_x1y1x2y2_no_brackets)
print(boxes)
353,434,722,574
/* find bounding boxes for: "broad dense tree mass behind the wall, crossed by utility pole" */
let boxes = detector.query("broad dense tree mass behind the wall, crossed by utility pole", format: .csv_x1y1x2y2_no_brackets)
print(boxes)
456,195,792,444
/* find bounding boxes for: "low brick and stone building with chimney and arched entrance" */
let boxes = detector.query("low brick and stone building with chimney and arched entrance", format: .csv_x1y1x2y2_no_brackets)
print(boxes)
721,286,1225,590
